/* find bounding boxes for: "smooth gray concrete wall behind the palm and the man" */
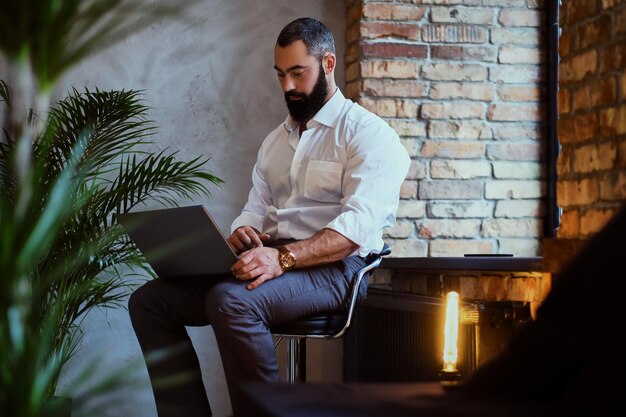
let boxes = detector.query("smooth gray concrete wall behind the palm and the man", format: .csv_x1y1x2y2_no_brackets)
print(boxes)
52,0,345,417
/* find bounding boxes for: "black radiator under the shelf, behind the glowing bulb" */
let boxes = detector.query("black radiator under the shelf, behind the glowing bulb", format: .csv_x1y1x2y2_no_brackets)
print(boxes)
343,288,478,382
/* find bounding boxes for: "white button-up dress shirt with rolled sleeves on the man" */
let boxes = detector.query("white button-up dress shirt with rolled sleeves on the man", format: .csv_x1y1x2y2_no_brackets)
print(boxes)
231,89,410,256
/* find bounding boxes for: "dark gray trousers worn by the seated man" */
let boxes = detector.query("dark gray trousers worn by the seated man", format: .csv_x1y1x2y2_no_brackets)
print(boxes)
128,256,367,417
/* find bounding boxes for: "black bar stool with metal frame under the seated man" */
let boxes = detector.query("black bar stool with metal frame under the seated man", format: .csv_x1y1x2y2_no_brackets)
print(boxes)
270,243,391,384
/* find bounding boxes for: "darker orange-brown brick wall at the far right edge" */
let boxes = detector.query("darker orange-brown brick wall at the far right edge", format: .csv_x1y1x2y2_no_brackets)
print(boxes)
557,0,626,238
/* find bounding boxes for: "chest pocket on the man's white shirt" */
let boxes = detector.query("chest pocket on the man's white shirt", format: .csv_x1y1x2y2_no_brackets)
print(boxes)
304,161,343,202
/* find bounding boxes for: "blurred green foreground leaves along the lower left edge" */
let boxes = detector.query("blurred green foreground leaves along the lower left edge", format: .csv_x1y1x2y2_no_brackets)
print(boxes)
0,114,92,417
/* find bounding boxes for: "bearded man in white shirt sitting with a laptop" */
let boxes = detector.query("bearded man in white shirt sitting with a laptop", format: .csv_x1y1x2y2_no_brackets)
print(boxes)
129,18,410,417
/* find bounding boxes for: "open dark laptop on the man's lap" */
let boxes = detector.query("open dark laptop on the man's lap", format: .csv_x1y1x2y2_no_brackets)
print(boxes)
118,205,237,278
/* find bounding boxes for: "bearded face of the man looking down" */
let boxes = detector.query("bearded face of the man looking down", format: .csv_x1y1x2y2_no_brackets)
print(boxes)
274,41,328,122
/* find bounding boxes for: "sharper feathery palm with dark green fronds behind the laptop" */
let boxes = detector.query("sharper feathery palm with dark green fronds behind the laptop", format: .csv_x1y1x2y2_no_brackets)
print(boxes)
0,81,222,415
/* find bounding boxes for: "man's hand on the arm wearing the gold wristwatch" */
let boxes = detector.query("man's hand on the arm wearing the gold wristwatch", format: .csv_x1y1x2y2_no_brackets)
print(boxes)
231,247,283,290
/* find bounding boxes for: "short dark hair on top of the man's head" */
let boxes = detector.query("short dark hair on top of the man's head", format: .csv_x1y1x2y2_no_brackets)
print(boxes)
276,17,335,62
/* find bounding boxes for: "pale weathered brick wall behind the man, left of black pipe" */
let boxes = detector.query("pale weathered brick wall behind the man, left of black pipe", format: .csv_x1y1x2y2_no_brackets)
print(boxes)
345,0,545,256
